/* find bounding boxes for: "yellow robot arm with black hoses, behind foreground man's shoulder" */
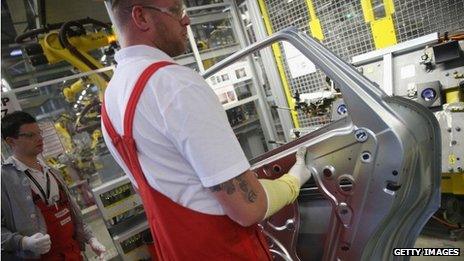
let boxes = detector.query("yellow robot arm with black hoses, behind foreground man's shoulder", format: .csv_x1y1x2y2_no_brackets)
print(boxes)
16,18,116,101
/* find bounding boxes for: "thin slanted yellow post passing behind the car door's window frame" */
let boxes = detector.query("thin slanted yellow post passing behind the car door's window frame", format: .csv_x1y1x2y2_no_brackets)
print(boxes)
258,0,300,128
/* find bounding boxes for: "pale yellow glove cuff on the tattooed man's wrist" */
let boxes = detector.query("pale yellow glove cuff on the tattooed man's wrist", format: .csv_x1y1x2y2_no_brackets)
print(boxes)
259,174,300,219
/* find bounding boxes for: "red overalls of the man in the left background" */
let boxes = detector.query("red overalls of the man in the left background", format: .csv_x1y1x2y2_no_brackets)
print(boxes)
32,172,83,261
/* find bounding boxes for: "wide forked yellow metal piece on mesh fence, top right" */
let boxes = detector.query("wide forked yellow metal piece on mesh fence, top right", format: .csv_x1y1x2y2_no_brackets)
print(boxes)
361,0,397,49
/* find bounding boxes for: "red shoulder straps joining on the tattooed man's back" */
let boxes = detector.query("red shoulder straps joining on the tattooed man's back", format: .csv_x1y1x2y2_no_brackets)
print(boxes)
101,61,173,179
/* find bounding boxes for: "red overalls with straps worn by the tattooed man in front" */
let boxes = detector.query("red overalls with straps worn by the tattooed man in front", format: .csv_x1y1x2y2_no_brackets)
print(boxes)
101,62,271,261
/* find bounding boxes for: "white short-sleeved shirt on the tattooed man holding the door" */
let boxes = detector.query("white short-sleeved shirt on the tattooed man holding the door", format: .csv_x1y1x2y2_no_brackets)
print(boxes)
103,45,250,215
